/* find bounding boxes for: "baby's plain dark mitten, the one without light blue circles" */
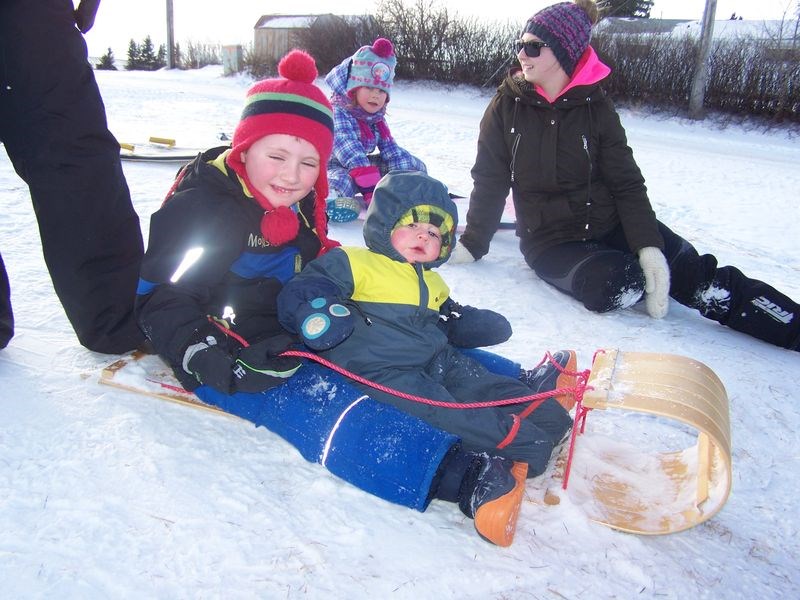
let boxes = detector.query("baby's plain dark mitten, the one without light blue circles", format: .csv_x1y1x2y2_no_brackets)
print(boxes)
439,299,512,348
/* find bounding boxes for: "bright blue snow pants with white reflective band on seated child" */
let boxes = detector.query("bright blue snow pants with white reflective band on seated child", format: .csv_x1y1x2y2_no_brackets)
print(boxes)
194,362,458,511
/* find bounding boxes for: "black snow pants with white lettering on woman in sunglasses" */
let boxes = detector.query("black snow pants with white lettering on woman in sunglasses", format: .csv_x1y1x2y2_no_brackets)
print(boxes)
528,222,800,350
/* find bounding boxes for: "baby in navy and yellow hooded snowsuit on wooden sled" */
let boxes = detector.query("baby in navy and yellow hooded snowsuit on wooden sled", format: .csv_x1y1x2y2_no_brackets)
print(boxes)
278,172,575,476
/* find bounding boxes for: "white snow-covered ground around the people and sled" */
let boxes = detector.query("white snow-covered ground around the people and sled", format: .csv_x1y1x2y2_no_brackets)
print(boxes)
0,63,800,600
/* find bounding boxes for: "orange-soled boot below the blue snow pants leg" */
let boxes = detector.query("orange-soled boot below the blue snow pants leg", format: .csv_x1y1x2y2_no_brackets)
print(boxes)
461,455,528,546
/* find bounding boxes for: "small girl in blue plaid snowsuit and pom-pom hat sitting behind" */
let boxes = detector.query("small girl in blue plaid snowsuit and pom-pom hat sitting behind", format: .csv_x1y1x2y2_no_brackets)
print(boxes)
325,38,426,223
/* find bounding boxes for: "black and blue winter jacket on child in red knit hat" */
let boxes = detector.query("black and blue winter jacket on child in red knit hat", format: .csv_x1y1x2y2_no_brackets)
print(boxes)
136,148,320,387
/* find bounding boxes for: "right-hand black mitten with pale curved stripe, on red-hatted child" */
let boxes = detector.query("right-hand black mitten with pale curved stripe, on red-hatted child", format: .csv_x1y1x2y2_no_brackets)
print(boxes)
233,334,300,392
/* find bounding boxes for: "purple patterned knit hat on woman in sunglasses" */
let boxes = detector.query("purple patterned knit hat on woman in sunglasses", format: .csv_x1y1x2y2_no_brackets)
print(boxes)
525,2,592,77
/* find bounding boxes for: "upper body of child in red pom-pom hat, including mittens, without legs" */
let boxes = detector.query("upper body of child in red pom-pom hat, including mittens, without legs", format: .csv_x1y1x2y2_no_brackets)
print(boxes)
137,51,338,394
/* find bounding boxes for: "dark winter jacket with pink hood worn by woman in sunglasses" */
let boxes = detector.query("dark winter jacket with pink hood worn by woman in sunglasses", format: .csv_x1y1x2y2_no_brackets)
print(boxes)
460,48,663,263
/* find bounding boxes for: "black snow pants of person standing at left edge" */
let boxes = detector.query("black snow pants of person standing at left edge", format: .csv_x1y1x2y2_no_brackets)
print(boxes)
0,0,144,354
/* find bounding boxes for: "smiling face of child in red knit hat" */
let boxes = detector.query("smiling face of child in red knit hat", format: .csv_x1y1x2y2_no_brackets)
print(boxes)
242,133,320,208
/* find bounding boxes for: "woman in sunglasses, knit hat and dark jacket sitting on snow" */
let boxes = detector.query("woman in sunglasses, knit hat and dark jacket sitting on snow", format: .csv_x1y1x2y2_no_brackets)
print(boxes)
450,0,800,350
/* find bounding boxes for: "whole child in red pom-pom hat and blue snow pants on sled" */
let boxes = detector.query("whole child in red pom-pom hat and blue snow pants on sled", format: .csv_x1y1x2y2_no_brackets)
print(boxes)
136,51,536,545
